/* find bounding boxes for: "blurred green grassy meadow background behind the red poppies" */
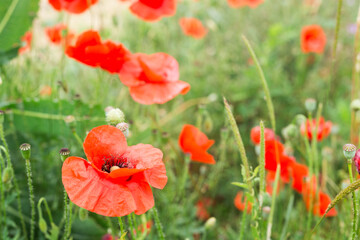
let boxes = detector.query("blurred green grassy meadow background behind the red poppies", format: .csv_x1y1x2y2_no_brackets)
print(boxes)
0,0,359,239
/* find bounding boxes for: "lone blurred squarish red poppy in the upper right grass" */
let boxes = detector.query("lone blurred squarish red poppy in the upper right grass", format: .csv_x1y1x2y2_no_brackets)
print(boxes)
301,25,326,53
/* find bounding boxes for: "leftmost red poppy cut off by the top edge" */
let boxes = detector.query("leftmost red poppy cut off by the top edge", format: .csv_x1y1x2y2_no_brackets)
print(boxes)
49,0,98,13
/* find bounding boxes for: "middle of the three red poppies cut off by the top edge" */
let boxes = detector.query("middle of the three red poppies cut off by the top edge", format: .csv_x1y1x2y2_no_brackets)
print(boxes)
130,0,177,22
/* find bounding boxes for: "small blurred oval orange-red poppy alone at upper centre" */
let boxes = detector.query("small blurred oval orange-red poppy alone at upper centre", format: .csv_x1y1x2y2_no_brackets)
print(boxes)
179,18,208,39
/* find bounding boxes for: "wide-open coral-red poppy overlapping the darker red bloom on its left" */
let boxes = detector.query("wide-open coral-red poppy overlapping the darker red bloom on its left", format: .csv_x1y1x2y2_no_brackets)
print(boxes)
119,53,190,104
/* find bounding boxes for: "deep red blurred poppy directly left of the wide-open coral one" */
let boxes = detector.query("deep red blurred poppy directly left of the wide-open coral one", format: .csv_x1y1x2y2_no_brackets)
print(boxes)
66,30,131,73
